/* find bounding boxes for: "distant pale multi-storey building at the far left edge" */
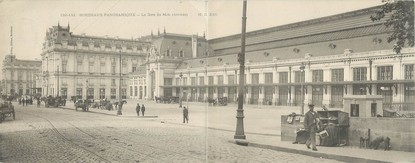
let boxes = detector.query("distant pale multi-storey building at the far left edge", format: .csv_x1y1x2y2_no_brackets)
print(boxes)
2,55,42,96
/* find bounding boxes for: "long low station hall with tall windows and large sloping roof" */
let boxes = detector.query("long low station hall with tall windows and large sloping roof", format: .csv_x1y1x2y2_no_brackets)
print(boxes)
150,7,415,108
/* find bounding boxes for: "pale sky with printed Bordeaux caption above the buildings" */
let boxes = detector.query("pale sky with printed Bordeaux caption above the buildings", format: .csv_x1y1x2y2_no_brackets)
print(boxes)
0,0,382,78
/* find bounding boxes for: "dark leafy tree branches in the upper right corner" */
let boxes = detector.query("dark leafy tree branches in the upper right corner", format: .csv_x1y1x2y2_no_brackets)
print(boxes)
370,0,414,47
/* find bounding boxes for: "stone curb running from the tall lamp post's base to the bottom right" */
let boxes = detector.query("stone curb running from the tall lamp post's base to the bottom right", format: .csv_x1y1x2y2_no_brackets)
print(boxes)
228,140,387,163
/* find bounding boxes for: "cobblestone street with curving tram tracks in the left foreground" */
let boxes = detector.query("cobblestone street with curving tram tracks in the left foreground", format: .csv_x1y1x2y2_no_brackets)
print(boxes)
0,104,344,162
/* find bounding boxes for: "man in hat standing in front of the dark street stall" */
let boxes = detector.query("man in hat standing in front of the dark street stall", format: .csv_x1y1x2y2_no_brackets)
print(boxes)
304,104,319,151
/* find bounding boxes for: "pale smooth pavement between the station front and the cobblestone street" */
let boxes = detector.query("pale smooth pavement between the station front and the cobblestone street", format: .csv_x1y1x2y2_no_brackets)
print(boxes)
61,100,415,162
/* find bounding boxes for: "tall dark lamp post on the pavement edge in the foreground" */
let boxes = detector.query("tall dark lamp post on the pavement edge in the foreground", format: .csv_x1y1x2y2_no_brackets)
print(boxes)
233,0,247,141
